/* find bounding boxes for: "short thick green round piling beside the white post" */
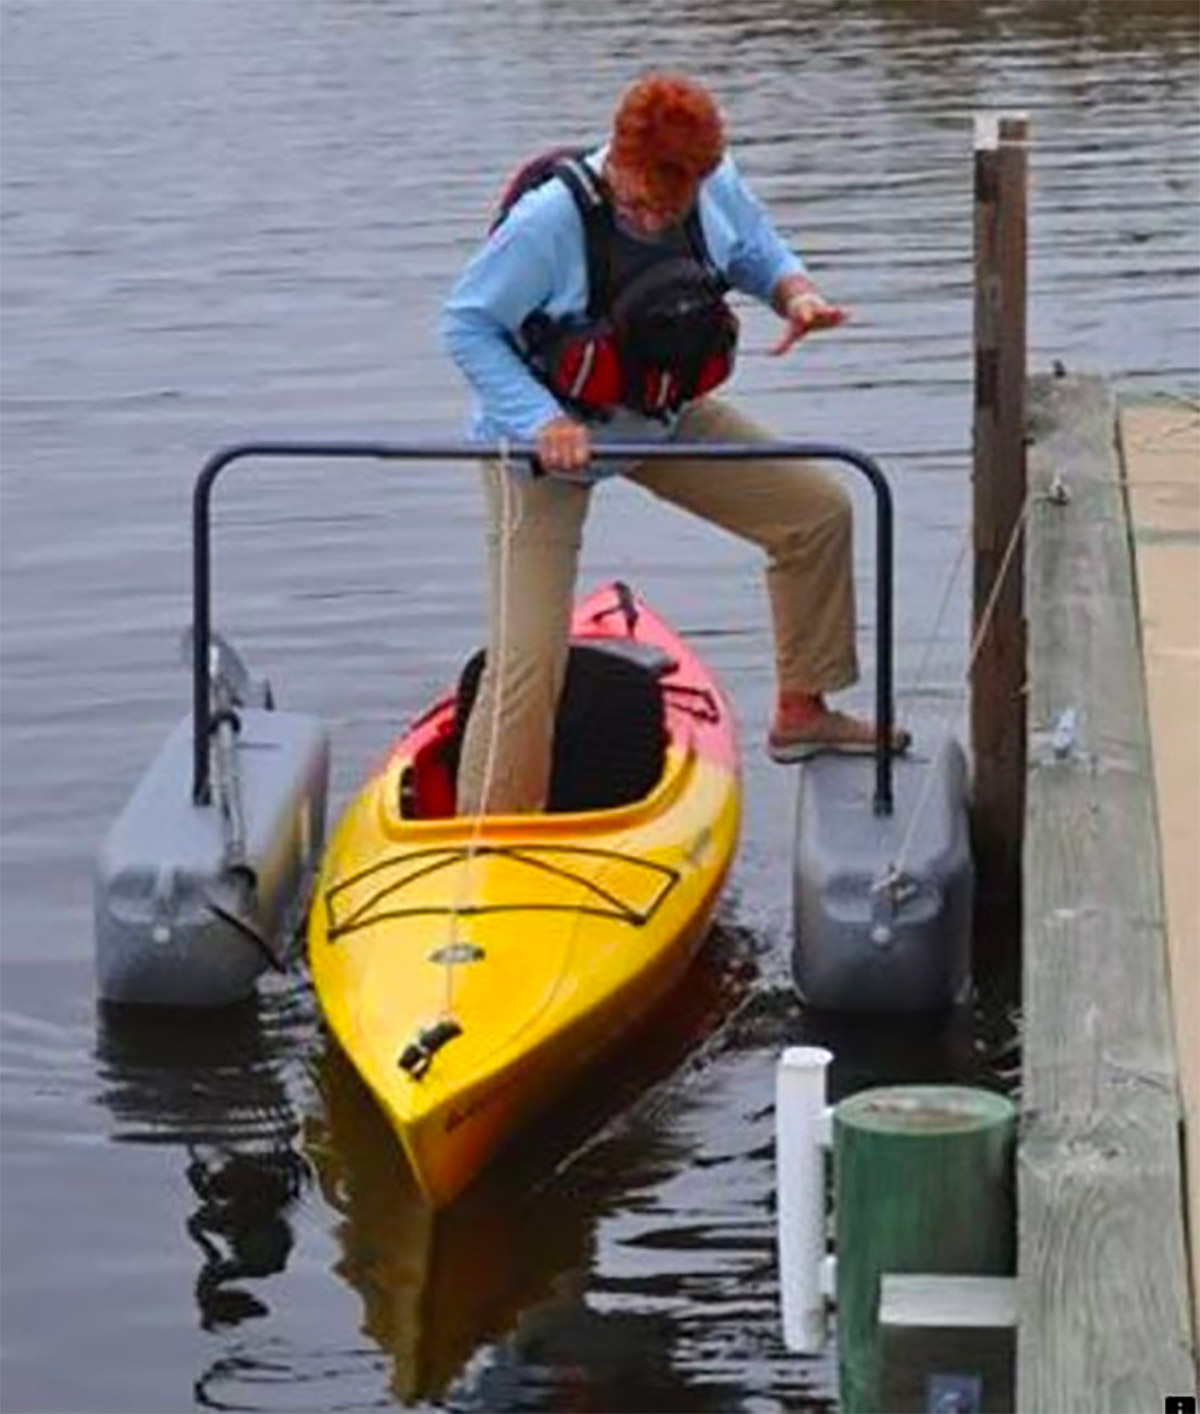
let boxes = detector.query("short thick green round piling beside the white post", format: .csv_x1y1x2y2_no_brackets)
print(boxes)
834,1085,1016,1414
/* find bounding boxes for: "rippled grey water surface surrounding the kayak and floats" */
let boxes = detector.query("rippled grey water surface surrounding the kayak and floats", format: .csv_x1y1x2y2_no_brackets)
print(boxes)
0,0,1200,1414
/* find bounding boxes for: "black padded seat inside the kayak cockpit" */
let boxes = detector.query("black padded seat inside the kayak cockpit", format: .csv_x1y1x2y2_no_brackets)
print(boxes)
447,638,677,813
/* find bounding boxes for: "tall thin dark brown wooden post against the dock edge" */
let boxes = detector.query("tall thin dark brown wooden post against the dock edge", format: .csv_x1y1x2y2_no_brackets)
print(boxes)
971,115,1029,969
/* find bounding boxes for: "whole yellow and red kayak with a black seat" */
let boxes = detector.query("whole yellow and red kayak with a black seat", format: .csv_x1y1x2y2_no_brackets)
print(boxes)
308,584,741,1208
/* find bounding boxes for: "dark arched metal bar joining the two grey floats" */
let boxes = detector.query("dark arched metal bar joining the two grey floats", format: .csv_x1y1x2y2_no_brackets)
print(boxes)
192,441,893,814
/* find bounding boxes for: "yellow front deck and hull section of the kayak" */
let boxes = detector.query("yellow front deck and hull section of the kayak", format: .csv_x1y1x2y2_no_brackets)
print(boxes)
310,585,741,1206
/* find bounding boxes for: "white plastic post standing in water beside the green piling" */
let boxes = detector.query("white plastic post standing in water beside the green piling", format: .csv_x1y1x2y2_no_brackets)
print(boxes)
775,1046,833,1355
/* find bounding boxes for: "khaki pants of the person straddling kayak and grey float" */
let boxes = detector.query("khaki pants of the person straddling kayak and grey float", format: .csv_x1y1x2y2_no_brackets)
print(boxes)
458,397,858,814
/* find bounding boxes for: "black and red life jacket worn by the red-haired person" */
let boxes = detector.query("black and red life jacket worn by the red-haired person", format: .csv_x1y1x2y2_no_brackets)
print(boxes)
490,147,738,419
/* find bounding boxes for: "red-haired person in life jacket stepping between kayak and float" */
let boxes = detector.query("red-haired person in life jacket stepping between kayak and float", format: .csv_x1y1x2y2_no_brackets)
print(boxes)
442,74,909,814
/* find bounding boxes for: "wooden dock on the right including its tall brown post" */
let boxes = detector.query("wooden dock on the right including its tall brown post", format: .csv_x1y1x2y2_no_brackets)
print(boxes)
859,113,1200,1414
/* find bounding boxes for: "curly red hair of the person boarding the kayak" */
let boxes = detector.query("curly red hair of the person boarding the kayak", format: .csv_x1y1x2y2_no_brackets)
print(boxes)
609,74,725,199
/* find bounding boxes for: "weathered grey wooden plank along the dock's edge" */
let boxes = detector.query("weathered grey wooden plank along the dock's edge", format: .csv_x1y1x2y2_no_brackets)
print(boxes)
1018,378,1196,1414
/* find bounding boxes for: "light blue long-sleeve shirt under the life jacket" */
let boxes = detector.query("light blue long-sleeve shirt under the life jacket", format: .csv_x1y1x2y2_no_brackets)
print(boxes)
441,148,804,475
